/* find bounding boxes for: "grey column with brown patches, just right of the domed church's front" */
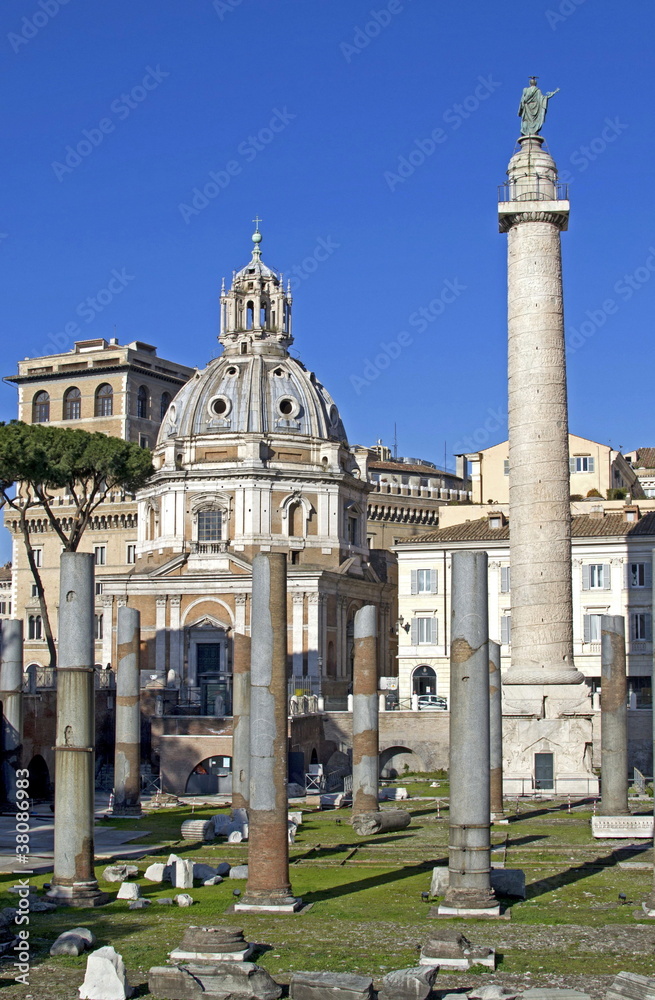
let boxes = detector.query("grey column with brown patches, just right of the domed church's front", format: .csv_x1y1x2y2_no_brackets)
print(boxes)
353,604,379,817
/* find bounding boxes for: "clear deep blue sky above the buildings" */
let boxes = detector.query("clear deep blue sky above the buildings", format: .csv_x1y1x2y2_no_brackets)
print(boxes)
0,0,655,466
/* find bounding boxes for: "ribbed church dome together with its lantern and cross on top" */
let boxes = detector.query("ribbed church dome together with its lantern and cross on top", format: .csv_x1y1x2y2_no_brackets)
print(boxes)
158,229,347,446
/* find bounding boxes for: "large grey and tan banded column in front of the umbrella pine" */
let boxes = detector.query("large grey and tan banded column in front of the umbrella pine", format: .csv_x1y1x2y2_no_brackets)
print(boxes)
48,552,109,906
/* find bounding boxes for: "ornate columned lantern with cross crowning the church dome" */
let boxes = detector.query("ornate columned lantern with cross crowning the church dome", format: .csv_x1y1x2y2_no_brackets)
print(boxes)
218,223,293,357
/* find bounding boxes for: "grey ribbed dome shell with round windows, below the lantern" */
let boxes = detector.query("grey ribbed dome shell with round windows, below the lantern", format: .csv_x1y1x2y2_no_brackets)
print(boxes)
158,354,346,445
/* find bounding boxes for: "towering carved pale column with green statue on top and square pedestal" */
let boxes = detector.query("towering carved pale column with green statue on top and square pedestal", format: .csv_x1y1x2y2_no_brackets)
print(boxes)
499,77,597,794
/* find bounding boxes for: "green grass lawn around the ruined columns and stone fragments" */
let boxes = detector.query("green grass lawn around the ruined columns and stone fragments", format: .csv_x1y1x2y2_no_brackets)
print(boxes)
0,792,655,1000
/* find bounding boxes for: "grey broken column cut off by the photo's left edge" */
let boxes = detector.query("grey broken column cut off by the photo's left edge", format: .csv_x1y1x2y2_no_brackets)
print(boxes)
0,618,23,805
